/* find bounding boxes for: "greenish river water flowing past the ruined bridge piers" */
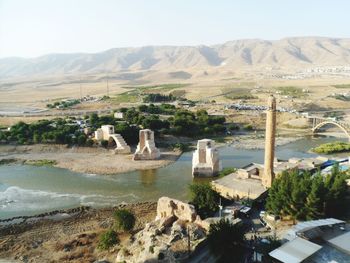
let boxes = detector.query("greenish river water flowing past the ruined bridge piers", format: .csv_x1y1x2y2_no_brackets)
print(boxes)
0,137,341,219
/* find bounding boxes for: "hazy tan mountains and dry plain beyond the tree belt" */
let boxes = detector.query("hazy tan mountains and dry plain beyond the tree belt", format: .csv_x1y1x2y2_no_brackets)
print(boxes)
0,37,350,121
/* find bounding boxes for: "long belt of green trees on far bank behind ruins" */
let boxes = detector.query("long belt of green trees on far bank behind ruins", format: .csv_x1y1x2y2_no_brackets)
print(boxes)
0,104,226,146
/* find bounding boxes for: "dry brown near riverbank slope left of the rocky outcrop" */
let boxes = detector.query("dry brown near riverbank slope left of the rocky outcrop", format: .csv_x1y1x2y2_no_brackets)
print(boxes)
0,202,156,262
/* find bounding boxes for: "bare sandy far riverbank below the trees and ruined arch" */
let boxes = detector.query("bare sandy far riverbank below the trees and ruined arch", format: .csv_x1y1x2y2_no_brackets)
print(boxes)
0,144,181,174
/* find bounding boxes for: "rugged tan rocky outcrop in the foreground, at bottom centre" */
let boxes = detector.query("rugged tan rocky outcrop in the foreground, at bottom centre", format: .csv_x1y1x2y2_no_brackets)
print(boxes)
115,197,206,263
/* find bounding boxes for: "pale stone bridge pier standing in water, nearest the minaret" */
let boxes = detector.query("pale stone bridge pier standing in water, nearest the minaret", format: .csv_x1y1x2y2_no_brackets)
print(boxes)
192,139,221,177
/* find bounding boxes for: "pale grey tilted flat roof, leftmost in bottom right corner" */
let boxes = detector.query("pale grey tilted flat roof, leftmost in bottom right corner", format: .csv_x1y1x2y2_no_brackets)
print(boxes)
269,237,322,263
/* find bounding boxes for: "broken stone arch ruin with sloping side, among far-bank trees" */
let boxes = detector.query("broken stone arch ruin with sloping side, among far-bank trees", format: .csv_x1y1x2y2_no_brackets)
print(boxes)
95,125,131,154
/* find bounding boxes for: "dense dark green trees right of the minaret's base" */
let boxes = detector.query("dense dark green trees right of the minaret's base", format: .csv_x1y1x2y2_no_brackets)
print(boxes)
266,164,350,220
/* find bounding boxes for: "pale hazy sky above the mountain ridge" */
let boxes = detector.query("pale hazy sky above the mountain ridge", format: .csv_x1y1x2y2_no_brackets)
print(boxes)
0,0,350,57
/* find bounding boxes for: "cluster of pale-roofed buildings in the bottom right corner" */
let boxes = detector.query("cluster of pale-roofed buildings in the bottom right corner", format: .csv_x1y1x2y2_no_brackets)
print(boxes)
269,218,350,263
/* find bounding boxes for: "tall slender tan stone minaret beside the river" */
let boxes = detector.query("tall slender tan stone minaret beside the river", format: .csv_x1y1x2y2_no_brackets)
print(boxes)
262,95,276,187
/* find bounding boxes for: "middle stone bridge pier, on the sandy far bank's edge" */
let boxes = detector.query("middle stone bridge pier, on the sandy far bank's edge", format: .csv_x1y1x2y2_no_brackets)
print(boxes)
134,129,160,160
